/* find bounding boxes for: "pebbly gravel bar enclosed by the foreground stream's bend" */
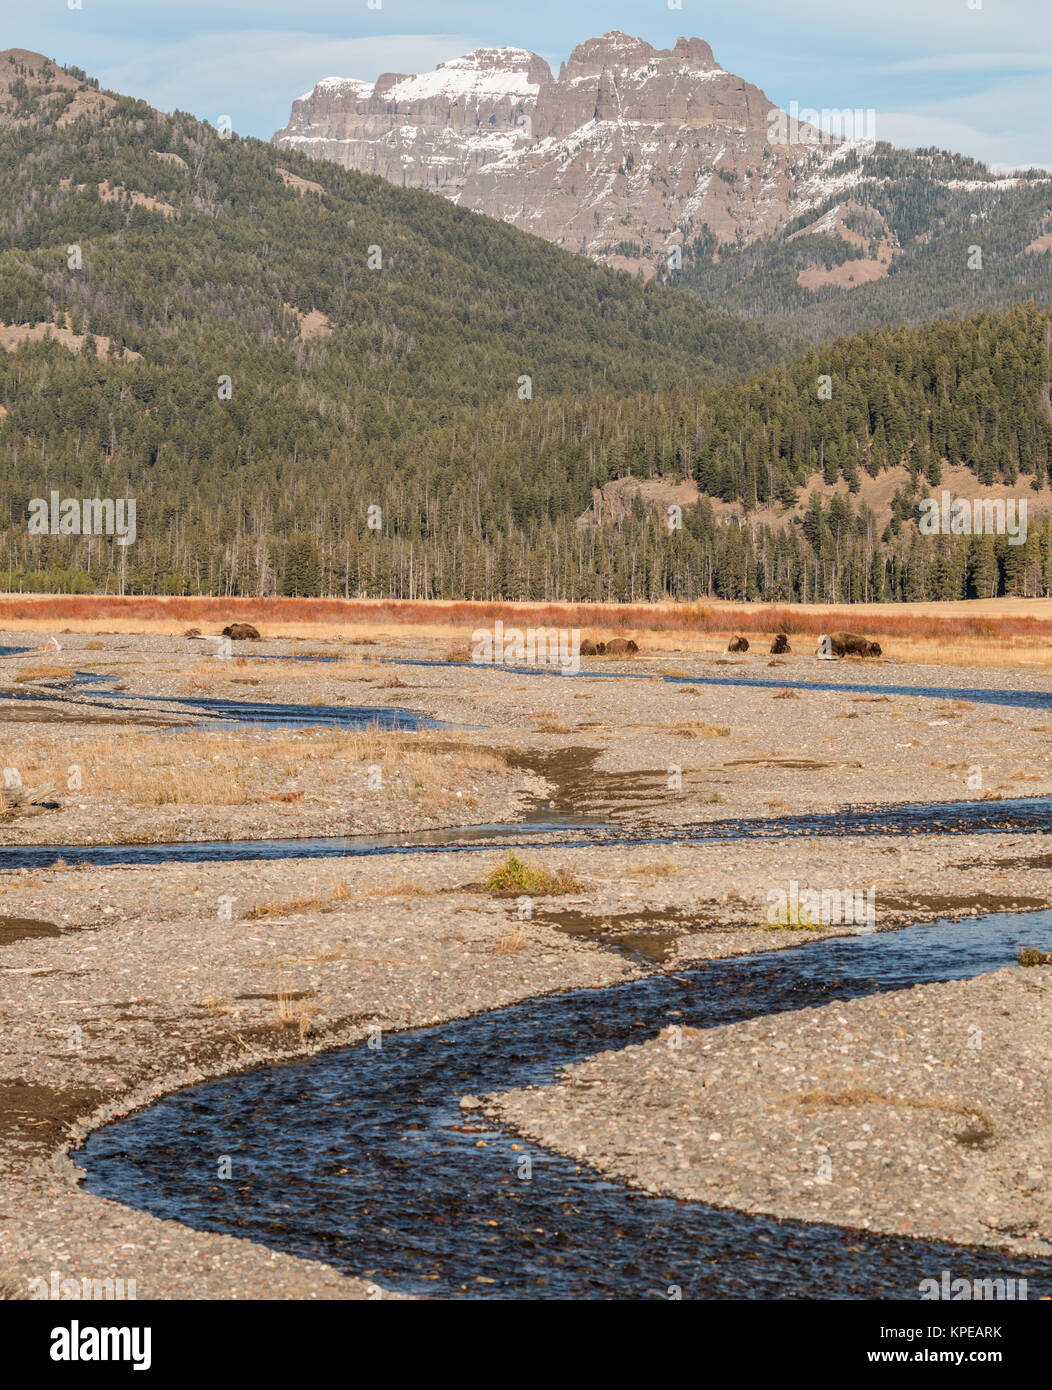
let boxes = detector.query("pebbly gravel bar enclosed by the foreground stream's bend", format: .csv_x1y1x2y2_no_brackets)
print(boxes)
488,966,1052,1276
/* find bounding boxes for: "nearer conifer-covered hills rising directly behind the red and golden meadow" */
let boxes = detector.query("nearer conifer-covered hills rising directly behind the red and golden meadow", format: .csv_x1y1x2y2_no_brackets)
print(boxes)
0,56,1052,599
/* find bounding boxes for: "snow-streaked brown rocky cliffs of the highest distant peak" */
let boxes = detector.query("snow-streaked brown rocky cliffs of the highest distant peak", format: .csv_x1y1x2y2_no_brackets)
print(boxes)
274,31,838,274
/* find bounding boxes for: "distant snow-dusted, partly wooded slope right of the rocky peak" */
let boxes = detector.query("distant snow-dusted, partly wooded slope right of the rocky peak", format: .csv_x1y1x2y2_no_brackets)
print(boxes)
661,145,1052,342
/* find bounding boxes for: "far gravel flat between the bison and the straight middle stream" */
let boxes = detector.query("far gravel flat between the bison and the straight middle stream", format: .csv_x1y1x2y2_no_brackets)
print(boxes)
0,632,1052,844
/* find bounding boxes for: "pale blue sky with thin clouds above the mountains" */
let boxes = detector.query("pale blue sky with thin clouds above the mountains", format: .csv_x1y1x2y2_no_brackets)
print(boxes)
0,0,1052,165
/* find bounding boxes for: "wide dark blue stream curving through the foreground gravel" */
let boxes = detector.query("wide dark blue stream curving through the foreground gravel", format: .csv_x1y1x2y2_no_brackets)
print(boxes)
75,912,1052,1300
